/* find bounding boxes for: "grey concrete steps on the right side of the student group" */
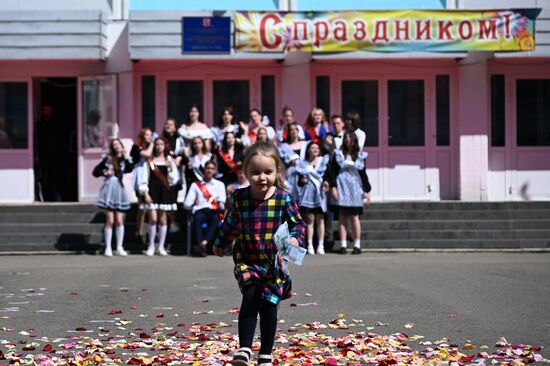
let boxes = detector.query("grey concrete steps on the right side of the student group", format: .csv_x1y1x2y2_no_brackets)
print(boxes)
327,202,550,249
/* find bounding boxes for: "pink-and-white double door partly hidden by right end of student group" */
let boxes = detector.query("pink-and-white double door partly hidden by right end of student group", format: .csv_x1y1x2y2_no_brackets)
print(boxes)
333,77,439,200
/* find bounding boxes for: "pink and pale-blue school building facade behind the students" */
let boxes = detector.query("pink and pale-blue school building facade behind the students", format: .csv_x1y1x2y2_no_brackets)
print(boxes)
0,0,550,203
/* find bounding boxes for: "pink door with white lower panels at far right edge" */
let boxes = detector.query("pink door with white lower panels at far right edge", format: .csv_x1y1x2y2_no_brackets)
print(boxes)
489,74,550,201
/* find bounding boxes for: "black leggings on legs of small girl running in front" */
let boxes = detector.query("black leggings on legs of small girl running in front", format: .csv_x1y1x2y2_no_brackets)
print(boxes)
239,284,277,355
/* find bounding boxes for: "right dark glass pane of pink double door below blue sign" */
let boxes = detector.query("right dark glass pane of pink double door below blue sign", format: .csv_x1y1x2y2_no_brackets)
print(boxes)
213,80,251,124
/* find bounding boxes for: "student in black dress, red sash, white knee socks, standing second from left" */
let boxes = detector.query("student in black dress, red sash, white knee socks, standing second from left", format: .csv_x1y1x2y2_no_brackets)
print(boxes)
139,137,179,256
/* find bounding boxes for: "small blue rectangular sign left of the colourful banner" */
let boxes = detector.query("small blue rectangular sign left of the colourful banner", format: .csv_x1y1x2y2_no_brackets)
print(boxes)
181,17,231,53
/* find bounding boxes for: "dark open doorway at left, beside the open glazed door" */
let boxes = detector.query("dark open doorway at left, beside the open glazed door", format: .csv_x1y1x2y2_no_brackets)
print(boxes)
34,78,78,202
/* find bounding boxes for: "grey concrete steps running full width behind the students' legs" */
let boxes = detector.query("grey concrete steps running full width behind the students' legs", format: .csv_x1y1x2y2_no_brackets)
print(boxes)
0,202,550,253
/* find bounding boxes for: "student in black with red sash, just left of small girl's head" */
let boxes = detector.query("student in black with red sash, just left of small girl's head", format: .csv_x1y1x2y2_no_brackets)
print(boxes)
216,132,244,186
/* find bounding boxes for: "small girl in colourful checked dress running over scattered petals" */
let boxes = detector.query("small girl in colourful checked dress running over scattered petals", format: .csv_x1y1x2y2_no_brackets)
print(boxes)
214,142,305,366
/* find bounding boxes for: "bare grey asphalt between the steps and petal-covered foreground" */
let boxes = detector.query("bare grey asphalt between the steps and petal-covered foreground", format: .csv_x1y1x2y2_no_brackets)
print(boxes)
0,253,550,363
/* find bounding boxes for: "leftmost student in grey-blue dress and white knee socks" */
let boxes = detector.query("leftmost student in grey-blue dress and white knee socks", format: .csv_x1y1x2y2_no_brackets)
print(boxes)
92,139,132,257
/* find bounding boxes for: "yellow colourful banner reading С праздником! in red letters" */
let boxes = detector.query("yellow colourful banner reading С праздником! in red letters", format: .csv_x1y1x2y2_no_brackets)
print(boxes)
235,9,540,52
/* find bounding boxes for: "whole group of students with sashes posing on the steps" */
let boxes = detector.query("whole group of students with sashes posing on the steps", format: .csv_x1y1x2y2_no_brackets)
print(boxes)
93,106,370,256
